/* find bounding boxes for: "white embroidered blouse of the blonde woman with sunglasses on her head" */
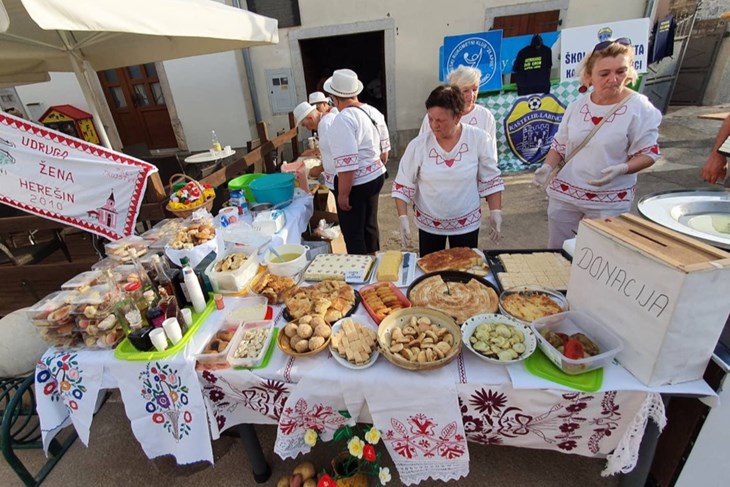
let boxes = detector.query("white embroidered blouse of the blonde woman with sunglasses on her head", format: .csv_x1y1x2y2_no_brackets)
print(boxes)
547,93,662,209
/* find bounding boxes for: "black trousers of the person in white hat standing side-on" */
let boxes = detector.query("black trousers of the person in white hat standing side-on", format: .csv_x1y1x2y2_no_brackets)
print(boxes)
334,174,385,255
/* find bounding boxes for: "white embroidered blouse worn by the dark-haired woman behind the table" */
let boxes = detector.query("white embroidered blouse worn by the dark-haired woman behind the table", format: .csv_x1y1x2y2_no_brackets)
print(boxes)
391,123,504,235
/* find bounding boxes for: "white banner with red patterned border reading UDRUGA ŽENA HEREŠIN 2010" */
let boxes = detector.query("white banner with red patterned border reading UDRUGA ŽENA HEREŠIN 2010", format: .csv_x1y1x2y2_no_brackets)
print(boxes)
0,113,157,240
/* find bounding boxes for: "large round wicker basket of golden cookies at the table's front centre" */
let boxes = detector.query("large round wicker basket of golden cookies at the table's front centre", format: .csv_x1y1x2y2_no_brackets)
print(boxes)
378,307,461,370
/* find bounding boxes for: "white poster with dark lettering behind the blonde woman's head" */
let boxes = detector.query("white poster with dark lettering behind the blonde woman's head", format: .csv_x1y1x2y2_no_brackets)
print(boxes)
560,18,651,81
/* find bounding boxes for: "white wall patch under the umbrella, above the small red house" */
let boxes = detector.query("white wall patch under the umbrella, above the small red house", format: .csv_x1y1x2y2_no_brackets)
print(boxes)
16,73,89,123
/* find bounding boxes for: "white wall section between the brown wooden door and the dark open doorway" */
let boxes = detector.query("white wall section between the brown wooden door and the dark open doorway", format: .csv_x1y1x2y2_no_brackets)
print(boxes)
163,51,251,152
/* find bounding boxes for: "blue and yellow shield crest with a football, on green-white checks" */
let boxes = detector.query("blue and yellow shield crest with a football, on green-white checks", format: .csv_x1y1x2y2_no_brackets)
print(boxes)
504,93,565,165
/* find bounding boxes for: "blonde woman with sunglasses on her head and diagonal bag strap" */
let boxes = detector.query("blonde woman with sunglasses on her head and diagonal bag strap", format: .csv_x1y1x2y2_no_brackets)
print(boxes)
533,38,662,248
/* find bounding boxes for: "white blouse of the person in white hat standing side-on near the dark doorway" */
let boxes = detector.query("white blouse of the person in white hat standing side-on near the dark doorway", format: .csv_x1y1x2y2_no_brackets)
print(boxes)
327,105,390,186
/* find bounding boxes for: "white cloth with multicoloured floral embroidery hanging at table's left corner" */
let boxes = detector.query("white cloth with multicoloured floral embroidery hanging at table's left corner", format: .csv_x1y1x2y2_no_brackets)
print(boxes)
35,349,213,464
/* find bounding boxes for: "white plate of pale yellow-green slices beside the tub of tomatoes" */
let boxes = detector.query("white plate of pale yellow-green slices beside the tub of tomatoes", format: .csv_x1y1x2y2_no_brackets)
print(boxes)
461,314,537,365
